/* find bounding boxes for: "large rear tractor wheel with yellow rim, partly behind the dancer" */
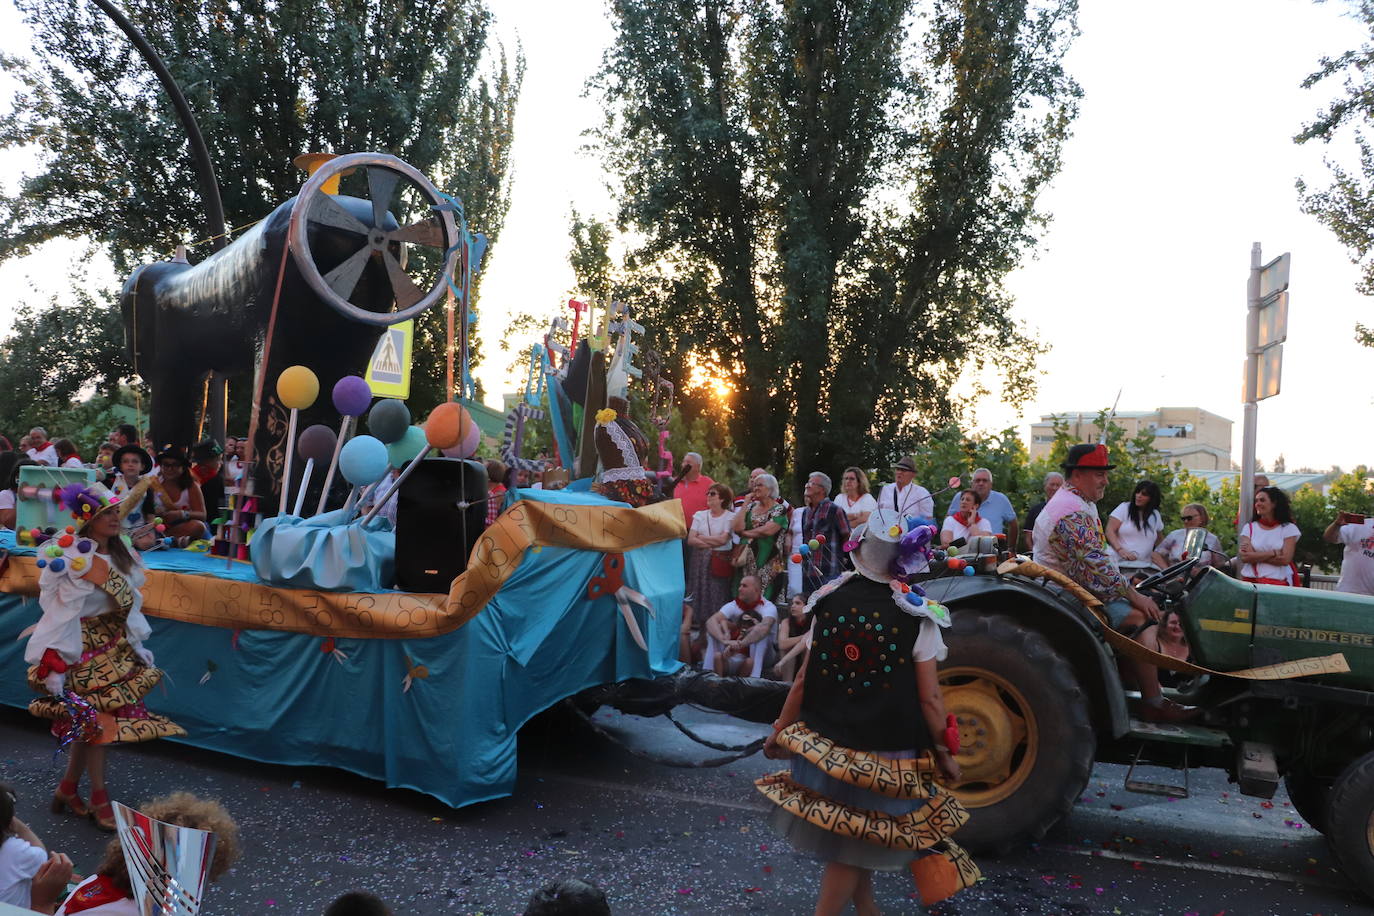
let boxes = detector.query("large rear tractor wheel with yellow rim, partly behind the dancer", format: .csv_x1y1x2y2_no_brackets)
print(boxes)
940,608,1096,854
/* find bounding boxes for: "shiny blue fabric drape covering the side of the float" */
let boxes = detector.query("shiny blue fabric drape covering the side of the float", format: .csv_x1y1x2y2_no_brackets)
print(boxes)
0,490,683,806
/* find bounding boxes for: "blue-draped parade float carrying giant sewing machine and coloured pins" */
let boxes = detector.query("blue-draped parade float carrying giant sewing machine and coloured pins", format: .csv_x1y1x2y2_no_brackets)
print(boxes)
0,154,785,806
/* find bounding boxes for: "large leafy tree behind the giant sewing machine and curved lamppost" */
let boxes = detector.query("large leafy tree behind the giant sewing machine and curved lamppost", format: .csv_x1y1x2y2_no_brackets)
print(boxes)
0,0,525,405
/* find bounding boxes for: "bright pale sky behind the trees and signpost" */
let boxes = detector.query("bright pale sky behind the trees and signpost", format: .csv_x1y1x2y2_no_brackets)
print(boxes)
0,0,1374,468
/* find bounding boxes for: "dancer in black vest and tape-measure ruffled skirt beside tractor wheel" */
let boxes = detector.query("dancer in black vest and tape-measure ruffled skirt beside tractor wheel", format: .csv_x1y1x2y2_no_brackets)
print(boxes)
757,507,978,916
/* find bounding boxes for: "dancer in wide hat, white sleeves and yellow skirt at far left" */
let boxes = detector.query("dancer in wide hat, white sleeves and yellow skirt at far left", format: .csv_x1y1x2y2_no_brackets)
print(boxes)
23,483,185,831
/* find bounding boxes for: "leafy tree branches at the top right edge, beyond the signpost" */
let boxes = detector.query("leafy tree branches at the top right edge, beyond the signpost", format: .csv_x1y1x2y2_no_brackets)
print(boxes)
1294,0,1374,340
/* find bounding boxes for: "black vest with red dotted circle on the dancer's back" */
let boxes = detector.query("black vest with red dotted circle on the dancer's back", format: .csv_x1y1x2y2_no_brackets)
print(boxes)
801,575,933,751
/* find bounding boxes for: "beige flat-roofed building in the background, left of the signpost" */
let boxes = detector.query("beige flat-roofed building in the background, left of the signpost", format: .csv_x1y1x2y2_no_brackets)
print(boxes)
1031,407,1231,471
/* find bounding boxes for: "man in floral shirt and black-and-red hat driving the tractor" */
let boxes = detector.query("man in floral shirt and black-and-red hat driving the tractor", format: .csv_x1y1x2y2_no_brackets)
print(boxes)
1035,445,1198,722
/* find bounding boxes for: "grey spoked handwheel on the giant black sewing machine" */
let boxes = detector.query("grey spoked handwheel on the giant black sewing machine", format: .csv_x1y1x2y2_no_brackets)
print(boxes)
287,152,458,327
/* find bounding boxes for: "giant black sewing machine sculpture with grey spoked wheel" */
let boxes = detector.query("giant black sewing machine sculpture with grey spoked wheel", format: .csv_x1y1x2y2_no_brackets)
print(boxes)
121,152,458,511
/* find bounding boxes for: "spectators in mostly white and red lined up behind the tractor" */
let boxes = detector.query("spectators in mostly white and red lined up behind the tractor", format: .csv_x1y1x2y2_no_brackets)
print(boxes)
673,452,1374,681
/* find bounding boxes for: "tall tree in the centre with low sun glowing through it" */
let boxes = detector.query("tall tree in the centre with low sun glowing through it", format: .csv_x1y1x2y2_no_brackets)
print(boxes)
591,0,1080,491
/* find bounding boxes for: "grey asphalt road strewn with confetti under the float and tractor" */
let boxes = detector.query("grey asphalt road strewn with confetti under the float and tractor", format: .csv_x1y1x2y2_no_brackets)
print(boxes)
0,709,1370,916
